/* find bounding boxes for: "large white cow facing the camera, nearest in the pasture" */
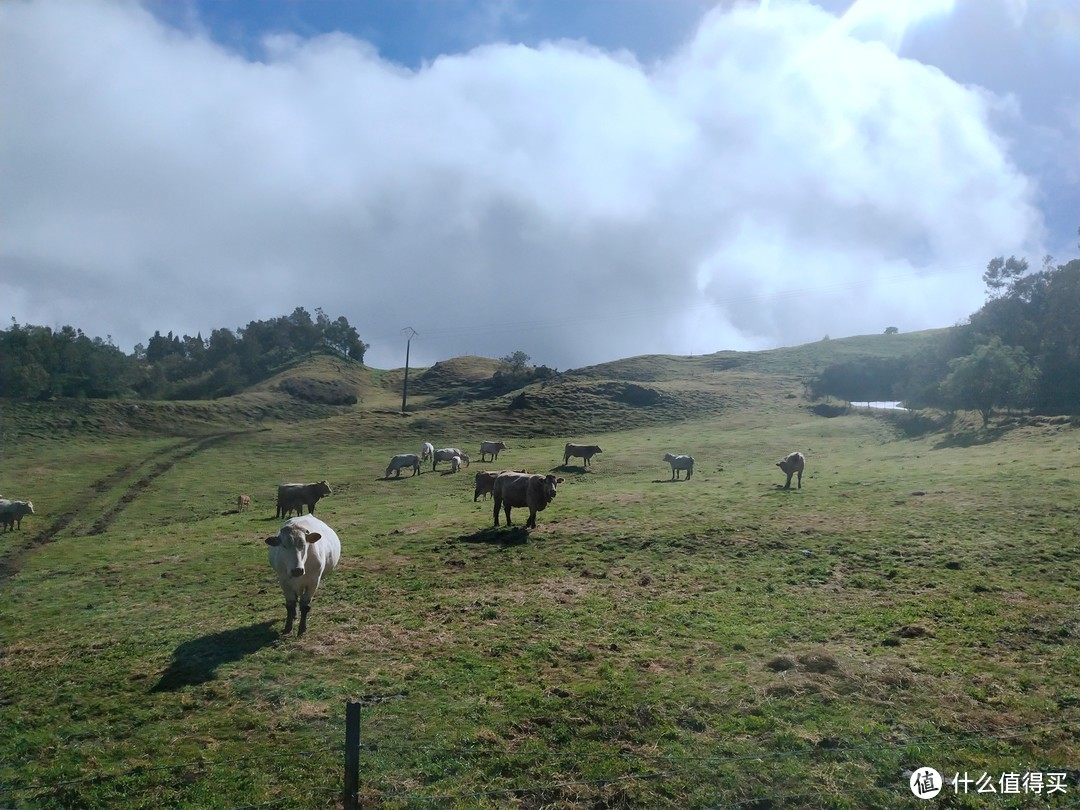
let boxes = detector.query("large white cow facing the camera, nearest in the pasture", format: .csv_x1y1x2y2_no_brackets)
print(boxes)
267,515,341,636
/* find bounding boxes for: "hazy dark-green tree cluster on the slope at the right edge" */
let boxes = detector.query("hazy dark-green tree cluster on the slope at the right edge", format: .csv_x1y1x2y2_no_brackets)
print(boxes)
810,250,1080,426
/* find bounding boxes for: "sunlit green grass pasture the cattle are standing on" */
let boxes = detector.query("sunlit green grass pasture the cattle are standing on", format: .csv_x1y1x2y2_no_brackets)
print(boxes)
0,336,1080,808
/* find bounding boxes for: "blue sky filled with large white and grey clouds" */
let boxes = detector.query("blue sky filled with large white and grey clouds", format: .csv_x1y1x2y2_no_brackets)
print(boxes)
0,0,1080,370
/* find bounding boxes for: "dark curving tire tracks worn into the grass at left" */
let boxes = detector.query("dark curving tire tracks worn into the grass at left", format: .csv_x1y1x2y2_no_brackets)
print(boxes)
0,431,245,584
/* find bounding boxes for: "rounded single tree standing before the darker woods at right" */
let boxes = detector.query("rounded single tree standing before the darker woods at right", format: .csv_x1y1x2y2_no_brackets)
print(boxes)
942,337,1037,428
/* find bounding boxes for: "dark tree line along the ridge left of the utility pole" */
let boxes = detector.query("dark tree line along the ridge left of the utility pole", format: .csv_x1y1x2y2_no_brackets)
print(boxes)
0,307,368,400
